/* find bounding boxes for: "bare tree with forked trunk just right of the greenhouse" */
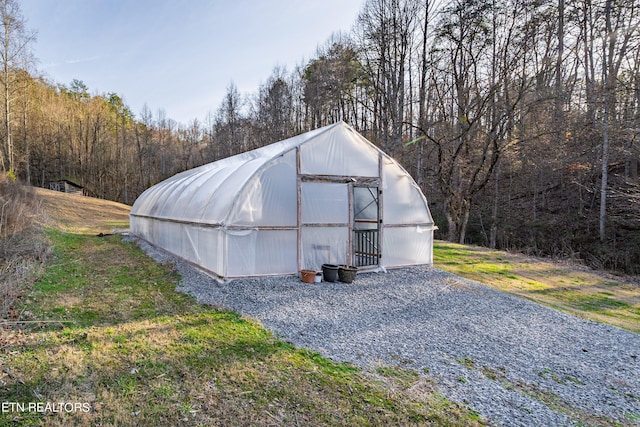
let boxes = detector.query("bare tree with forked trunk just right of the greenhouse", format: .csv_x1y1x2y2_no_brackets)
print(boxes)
423,0,532,243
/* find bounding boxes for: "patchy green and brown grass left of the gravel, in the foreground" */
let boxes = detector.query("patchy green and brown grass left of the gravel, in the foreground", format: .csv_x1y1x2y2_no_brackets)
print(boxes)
0,229,484,426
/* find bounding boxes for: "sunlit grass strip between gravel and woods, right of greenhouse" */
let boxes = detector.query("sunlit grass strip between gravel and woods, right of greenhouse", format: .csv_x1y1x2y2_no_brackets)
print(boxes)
434,241,640,333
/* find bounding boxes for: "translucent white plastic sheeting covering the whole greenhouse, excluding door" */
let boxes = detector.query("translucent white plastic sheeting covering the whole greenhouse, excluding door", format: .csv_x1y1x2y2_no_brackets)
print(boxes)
131,122,434,278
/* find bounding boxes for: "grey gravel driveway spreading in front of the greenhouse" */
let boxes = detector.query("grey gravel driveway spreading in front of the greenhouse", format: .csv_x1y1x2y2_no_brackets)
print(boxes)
131,242,640,426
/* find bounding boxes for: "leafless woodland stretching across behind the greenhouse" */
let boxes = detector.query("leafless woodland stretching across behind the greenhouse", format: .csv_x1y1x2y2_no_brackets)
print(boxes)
0,0,640,273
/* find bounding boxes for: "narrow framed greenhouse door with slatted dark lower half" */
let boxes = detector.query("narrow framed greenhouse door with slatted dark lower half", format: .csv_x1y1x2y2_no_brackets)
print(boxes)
353,186,380,267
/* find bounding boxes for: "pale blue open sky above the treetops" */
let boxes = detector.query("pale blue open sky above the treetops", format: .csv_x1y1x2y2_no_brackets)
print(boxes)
20,0,364,124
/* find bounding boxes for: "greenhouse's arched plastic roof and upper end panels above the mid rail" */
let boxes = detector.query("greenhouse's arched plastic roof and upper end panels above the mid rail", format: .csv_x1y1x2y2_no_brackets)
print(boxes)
131,122,432,227
